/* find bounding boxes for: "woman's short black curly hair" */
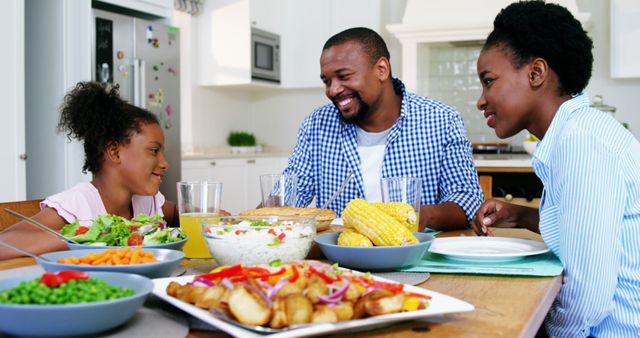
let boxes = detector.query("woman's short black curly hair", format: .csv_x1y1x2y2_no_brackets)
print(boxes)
483,0,593,95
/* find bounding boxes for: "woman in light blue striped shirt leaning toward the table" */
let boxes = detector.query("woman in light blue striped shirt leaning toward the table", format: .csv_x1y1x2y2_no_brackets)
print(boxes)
472,1,640,337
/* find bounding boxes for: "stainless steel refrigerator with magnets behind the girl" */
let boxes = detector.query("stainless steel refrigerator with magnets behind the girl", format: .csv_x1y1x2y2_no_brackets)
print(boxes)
93,9,181,201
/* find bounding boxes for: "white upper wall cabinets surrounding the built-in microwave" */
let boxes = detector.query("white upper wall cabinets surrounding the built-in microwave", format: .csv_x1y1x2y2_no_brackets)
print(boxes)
197,0,381,88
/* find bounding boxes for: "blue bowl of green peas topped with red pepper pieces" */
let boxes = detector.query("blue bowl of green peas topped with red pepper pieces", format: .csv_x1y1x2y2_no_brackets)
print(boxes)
0,270,153,337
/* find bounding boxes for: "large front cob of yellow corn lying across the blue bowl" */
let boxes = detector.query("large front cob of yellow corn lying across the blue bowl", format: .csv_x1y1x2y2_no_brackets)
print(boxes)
342,198,418,246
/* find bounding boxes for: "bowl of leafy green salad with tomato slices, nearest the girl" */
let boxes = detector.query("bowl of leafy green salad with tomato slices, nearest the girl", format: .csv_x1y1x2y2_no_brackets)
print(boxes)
60,214,188,250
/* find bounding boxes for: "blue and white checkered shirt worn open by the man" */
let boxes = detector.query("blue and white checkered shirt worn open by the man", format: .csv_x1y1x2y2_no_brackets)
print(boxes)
284,79,483,221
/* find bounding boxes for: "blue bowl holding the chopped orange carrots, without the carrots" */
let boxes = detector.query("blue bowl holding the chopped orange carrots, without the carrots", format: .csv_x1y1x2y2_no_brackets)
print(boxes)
38,247,184,278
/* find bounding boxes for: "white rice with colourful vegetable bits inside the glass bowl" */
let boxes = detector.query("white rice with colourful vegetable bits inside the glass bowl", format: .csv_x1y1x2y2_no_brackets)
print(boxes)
205,222,315,265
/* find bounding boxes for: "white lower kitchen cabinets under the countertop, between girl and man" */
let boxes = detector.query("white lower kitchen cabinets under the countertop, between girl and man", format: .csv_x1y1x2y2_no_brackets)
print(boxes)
182,157,287,214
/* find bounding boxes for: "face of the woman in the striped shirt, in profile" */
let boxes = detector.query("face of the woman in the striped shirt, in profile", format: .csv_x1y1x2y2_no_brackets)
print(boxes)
477,46,535,138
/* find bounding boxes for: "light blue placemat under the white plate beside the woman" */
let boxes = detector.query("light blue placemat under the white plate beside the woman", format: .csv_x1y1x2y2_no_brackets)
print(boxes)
401,251,563,276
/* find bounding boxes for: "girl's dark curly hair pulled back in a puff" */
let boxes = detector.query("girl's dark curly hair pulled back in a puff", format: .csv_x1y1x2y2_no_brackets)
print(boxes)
58,82,158,174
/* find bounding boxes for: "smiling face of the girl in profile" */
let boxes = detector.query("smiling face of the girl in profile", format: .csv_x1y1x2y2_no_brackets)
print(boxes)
119,123,169,196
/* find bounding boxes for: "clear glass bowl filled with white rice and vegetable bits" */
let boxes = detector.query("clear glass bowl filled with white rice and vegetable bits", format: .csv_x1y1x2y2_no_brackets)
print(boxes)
202,216,316,265
